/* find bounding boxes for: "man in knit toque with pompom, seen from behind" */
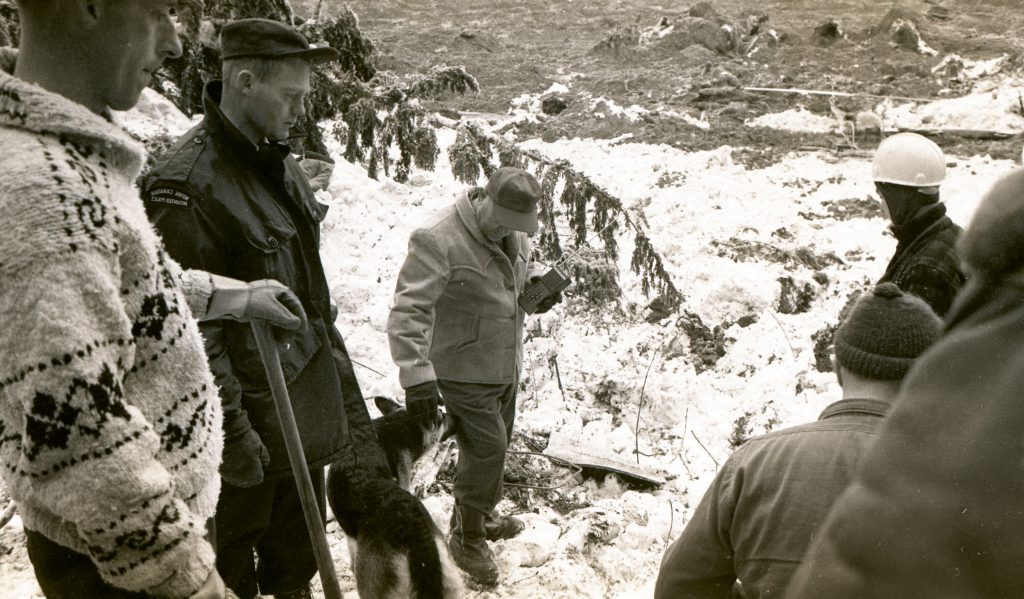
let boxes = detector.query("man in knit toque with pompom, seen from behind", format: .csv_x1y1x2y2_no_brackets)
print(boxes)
654,283,942,599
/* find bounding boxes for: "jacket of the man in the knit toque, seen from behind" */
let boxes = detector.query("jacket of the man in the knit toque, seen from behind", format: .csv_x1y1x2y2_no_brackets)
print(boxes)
654,399,889,599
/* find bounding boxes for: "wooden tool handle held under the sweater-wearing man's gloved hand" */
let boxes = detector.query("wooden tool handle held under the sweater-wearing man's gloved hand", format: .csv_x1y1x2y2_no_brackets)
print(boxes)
252,323,342,599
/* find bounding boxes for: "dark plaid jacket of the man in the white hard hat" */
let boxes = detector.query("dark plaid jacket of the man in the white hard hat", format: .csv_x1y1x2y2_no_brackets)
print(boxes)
879,203,965,316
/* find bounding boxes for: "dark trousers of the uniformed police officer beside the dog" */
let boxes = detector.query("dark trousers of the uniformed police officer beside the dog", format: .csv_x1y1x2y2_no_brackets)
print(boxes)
213,468,326,599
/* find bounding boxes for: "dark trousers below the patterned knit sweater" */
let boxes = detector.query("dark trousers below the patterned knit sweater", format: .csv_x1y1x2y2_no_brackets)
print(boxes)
25,528,147,599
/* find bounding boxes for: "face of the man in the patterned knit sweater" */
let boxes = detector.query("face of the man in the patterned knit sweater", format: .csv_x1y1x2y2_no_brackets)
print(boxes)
92,0,181,111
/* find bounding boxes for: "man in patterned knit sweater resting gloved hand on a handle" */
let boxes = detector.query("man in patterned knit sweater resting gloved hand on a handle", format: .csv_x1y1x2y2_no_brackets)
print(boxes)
0,0,304,598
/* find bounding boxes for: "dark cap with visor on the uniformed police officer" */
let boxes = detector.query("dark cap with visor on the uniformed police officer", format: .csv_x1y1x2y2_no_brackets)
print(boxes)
220,18,338,65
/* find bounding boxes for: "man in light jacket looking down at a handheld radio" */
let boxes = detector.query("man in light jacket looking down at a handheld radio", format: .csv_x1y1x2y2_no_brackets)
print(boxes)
387,167,561,584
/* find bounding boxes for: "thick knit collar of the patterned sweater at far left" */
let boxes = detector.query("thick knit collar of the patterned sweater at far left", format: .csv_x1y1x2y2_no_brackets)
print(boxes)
0,71,145,180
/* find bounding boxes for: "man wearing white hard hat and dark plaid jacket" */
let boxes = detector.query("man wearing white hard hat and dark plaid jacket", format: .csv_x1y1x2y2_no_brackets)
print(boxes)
871,133,965,316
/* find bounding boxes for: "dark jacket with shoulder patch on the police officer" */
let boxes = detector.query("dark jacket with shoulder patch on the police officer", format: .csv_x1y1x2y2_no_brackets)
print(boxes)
142,82,354,476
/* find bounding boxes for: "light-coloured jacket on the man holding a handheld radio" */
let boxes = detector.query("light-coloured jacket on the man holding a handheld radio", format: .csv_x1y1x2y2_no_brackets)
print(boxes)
387,189,539,388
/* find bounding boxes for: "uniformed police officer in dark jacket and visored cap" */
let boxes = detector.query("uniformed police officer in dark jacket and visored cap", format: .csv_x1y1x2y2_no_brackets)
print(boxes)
142,18,377,599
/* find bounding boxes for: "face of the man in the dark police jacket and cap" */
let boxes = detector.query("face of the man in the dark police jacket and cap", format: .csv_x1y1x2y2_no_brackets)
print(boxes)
246,58,310,141
